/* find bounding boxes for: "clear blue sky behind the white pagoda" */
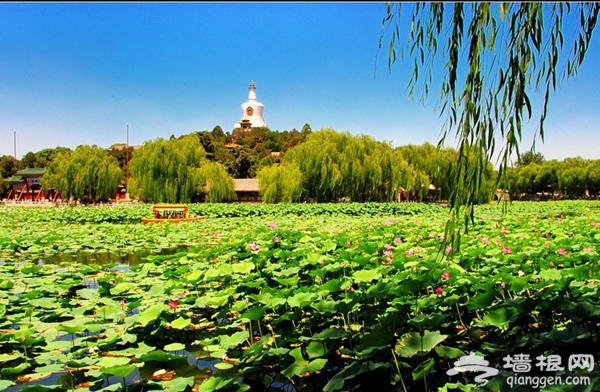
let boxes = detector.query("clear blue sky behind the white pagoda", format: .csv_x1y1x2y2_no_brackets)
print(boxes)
0,2,600,163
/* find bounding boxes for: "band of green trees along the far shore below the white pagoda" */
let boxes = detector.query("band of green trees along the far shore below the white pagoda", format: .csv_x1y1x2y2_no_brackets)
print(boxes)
0,124,600,203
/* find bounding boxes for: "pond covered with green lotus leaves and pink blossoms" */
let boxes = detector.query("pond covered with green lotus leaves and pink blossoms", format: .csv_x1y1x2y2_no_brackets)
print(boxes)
0,201,600,392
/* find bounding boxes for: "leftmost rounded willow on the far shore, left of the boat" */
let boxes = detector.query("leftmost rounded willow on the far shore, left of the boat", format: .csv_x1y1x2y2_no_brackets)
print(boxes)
42,145,124,203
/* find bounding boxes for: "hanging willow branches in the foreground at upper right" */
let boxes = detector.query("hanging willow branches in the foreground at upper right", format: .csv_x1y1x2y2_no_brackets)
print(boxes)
379,2,600,250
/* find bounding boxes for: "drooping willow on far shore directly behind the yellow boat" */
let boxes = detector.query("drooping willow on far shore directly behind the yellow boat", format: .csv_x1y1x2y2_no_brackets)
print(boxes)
129,134,208,203
